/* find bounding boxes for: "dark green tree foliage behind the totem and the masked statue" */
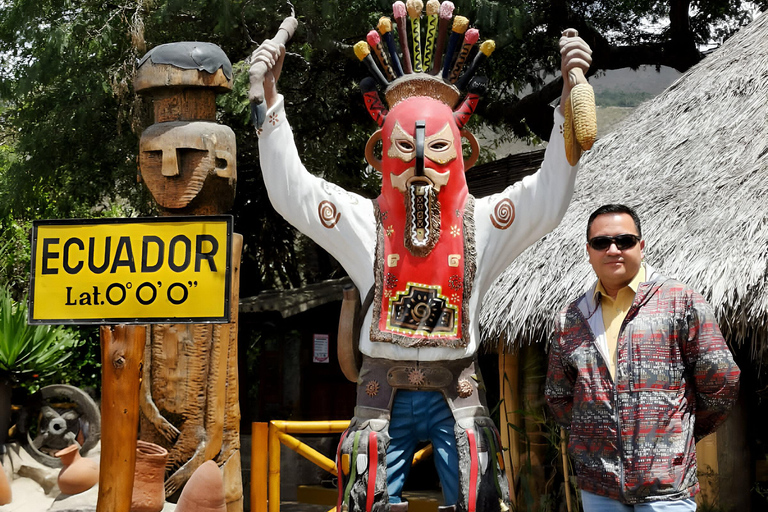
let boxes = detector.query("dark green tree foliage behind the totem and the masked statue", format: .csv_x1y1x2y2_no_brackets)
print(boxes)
0,0,768,295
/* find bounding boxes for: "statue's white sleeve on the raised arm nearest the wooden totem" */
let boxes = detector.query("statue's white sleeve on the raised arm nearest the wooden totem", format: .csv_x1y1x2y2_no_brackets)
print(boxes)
257,95,376,293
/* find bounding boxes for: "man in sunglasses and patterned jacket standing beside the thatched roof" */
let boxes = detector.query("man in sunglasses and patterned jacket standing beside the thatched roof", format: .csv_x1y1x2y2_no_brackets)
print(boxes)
545,204,739,512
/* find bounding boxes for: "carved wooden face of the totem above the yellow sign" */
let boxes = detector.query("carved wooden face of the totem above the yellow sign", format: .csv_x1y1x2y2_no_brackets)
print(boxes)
139,121,237,215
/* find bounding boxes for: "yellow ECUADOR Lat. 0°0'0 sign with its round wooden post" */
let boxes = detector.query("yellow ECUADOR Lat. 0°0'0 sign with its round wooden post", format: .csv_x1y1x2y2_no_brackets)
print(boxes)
29,215,234,512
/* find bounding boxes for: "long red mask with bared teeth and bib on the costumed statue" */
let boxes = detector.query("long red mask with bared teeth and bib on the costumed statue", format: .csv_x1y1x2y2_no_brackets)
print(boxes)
371,77,474,347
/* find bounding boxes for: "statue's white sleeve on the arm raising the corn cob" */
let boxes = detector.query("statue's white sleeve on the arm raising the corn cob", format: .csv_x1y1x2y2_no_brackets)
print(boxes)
475,108,578,293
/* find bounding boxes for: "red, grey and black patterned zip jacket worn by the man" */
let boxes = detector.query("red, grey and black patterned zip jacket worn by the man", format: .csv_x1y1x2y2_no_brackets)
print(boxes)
545,267,740,504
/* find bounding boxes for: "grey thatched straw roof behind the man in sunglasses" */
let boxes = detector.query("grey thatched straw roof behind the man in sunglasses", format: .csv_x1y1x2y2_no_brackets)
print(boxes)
481,14,768,356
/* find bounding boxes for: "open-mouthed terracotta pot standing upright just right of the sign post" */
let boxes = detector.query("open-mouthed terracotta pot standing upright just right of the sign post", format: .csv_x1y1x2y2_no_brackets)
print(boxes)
131,440,168,512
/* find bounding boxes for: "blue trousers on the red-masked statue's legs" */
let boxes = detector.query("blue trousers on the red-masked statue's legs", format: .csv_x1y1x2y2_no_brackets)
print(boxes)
387,391,459,505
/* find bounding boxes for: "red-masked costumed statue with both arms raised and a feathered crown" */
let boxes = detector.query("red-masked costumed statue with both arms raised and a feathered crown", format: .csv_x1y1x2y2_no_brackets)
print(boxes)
251,0,591,512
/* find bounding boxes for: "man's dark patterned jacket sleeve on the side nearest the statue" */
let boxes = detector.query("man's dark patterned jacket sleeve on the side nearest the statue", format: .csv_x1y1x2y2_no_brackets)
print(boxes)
544,313,576,430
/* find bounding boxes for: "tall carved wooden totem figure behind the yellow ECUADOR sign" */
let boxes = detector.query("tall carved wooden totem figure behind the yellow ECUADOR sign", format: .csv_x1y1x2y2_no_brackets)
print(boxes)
134,42,243,512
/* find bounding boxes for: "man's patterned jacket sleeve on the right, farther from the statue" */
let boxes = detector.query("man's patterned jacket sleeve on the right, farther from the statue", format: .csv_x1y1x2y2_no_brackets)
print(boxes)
683,292,740,441
